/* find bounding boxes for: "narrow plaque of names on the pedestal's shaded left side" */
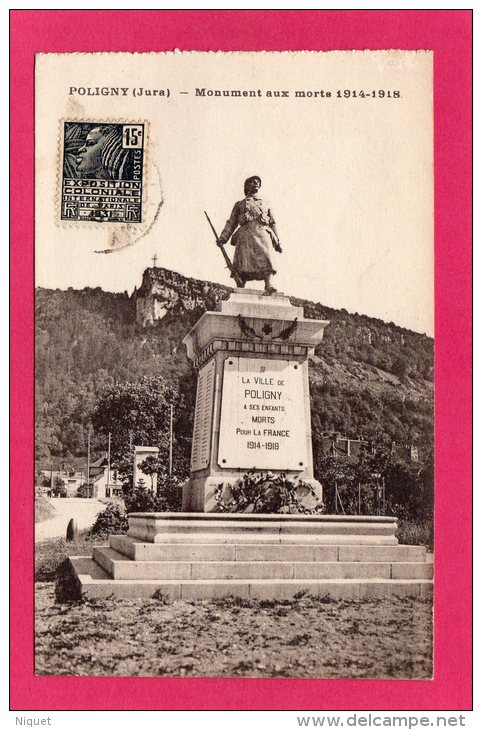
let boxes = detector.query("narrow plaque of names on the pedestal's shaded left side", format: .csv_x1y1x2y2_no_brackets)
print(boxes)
191,360,215,471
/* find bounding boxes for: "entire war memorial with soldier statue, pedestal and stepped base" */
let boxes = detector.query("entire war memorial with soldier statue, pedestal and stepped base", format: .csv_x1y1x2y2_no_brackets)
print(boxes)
70,176,433,600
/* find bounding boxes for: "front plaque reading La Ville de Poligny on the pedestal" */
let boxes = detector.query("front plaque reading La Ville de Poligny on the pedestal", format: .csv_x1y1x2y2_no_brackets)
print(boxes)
218,357,307,471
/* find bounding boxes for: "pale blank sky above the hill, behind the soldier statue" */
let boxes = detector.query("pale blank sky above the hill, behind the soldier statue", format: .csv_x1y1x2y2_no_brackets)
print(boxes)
36,51,433,335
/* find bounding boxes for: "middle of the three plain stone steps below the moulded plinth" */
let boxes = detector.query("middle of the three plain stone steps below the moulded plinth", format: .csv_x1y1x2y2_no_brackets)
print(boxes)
93,547,433,580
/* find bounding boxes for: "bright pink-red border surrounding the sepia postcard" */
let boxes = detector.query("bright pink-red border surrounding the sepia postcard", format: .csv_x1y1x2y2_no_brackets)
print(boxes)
10,10,472,711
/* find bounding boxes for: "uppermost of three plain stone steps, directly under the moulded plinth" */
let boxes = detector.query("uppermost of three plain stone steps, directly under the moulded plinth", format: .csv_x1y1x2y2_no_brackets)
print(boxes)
110,535,426,563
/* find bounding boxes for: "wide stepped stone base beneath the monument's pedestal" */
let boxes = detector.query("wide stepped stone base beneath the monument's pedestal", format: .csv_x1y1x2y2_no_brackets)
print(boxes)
70,513,433,600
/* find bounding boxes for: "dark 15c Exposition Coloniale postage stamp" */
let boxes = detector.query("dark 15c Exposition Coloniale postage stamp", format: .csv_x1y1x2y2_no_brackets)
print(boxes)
60,121,145,223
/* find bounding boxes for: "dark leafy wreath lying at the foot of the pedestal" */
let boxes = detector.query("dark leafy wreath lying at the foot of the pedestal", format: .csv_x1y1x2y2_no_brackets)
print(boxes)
214,471,325,515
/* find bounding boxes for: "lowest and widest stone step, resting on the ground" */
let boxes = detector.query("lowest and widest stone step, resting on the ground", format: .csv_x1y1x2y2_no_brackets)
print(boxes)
70,556,433,600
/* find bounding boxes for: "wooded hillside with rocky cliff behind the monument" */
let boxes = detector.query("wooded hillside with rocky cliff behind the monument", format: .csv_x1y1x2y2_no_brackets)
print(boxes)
36,268,433,472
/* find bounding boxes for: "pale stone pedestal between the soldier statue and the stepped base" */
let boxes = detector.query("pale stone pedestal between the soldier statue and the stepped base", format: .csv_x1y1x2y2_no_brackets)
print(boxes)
183,289,328,512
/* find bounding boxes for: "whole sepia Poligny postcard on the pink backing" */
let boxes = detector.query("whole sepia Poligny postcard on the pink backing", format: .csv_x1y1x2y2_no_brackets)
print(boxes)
34,50,434,680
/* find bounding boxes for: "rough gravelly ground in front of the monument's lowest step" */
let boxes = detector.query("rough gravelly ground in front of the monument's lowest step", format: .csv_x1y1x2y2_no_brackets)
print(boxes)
36,582,432,679
